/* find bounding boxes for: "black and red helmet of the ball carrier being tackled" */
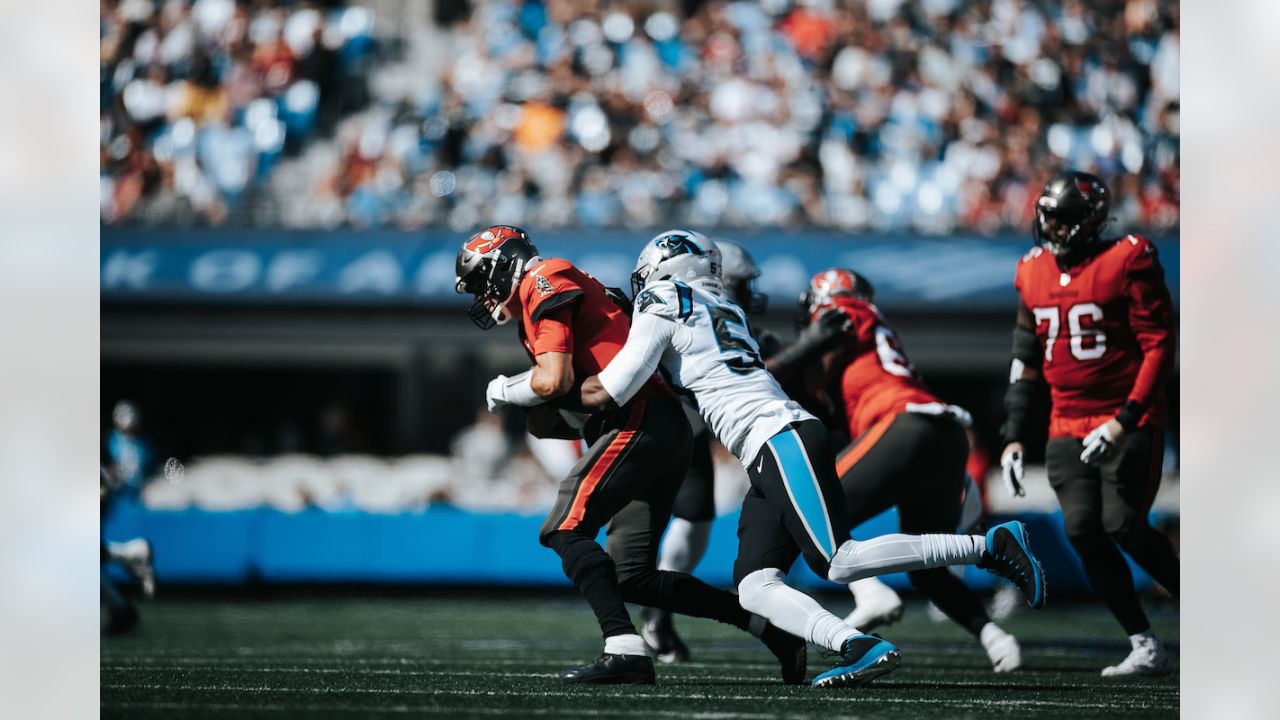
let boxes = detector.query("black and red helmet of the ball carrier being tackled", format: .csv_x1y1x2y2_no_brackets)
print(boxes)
453,225,538,331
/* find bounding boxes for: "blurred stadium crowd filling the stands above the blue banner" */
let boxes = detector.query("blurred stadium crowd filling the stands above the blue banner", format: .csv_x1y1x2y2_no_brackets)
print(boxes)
100,0,1179,233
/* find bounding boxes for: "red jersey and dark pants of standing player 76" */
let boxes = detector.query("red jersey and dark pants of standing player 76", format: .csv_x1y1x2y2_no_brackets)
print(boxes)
1006,234,1179,634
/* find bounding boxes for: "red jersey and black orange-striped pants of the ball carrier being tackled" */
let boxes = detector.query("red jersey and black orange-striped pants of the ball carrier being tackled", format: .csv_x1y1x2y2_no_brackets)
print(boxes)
516,259,750,637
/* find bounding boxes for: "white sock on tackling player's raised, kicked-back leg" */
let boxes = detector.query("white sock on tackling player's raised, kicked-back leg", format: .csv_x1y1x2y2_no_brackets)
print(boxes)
827,533,987,584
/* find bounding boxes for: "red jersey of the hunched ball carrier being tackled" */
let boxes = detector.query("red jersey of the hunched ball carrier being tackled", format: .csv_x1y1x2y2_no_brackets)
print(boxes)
516,258,669,397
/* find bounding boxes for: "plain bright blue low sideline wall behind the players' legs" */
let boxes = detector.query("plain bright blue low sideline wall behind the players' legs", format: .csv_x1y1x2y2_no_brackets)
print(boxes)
102,505,1161,593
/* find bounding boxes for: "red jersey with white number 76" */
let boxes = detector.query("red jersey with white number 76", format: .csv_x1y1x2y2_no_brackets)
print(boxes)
1014,234,1174,437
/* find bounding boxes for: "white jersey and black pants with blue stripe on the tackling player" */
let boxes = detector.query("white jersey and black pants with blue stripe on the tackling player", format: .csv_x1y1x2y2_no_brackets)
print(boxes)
599,281,849,578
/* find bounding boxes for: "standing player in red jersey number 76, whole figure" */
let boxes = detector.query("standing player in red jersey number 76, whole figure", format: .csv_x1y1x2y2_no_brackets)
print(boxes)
1000,170,1179,676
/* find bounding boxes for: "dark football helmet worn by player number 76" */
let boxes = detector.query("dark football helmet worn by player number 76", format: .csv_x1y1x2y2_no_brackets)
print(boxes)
1032,170,1111,260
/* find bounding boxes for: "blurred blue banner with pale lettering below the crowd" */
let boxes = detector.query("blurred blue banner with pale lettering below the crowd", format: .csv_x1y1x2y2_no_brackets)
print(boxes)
100,228,1179,313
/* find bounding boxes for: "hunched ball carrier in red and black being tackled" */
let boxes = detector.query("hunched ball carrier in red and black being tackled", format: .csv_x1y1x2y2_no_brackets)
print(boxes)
456,225,805,683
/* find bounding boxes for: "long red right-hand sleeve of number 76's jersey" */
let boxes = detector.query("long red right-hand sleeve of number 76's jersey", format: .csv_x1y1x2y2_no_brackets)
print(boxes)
1120,236,1175,407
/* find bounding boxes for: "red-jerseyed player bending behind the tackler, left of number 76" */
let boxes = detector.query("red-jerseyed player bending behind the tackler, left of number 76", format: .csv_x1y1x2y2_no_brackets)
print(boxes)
804,268,1021,673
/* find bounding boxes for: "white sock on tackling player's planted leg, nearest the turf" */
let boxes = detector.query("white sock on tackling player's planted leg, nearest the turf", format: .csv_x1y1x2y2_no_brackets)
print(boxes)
737,568,858,652
